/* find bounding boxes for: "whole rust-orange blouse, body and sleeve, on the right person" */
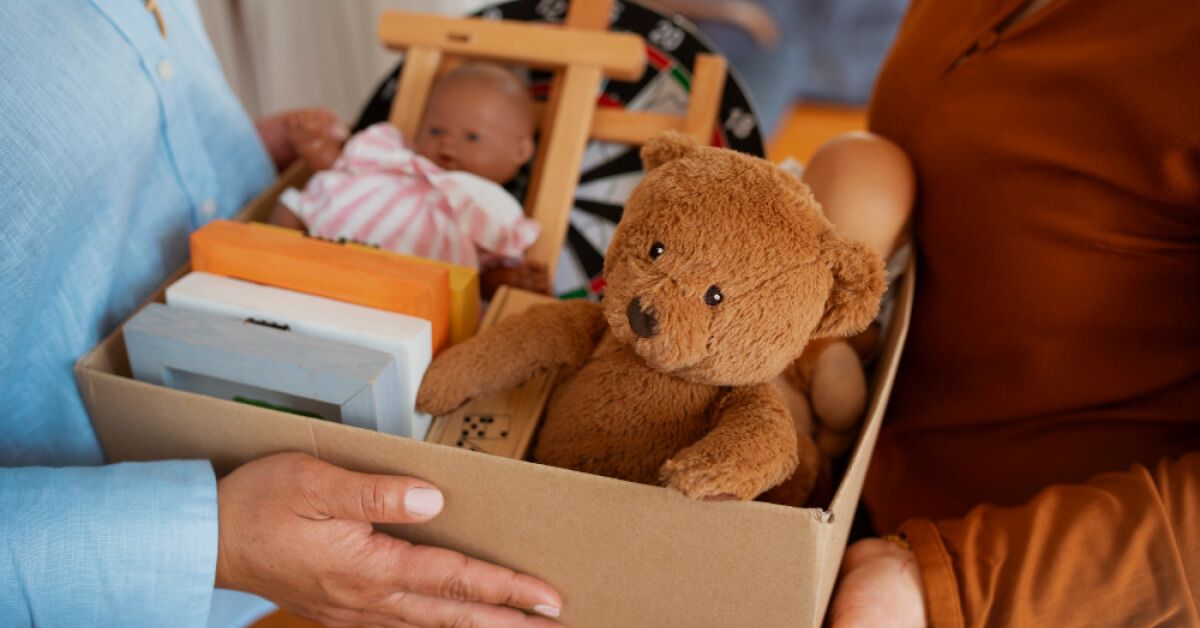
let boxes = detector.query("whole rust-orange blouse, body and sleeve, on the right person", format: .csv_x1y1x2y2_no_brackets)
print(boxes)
864,0,1200,626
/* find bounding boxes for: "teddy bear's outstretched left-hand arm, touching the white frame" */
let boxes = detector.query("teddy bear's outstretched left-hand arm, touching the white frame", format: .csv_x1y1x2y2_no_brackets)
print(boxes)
416,300,608,415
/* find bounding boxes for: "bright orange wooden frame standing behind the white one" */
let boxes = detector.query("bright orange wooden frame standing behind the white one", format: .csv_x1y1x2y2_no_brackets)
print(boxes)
191,221,450,353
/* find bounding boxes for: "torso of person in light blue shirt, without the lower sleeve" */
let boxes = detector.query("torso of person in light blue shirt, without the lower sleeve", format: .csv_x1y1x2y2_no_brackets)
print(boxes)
0,0,274,466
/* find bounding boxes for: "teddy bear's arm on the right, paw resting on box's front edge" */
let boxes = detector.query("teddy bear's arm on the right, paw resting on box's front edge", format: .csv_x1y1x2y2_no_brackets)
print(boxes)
660,383,799,500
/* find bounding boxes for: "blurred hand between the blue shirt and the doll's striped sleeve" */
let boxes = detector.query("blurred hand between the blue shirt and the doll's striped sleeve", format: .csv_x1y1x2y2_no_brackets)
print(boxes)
254,109,350,172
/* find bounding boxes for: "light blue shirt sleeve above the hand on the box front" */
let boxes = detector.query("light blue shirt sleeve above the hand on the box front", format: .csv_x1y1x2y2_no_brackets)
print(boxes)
0,461,217,626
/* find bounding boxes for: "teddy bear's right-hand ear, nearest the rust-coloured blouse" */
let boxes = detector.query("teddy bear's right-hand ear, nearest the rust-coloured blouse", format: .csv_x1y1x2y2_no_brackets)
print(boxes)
812,232,887,337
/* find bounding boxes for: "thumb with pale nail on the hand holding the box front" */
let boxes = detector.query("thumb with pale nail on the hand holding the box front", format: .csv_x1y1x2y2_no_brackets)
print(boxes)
305,465,445,524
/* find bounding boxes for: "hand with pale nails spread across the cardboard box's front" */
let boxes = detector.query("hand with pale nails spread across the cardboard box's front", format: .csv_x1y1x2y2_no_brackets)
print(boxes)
216,454,563,627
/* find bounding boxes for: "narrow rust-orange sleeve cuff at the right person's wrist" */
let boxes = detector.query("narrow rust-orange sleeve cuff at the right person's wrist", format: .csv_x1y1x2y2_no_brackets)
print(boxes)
900,519,966,628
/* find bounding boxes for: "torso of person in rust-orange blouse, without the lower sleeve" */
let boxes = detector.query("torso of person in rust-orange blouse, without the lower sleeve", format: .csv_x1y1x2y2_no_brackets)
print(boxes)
866,0,1200,526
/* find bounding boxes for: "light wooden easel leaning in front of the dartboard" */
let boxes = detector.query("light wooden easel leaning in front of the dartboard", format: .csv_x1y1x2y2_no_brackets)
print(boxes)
379,0,726,276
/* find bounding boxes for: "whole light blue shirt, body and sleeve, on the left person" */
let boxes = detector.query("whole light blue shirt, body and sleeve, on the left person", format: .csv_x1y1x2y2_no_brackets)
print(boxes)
0,0,274,626
